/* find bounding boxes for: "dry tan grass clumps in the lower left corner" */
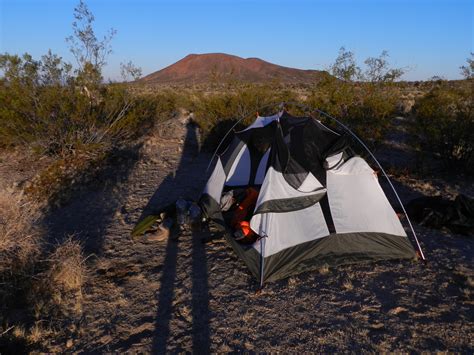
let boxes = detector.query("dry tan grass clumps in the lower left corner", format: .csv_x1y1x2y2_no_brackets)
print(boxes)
0,190,86,351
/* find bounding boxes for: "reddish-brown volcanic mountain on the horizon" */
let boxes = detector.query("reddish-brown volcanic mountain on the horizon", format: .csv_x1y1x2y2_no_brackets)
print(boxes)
140,53,328,85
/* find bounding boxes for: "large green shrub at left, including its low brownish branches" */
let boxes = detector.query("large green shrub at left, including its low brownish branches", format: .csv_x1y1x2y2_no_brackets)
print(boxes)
0,54,177,206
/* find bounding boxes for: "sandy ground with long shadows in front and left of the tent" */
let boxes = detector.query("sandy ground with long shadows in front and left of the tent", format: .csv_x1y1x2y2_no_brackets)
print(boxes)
41,114,474,353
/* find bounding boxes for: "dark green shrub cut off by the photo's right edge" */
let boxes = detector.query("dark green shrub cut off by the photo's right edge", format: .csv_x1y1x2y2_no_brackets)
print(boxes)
412,85,474,173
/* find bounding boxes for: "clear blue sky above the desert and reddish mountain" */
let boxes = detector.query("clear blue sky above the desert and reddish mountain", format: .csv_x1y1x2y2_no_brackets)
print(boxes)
0,0,474,80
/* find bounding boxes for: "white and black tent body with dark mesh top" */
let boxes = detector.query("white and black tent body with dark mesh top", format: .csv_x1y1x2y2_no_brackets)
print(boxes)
200,111,416,283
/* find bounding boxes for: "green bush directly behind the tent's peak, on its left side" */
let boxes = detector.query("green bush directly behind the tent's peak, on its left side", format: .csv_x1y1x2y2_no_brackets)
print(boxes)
189,85,295,149
